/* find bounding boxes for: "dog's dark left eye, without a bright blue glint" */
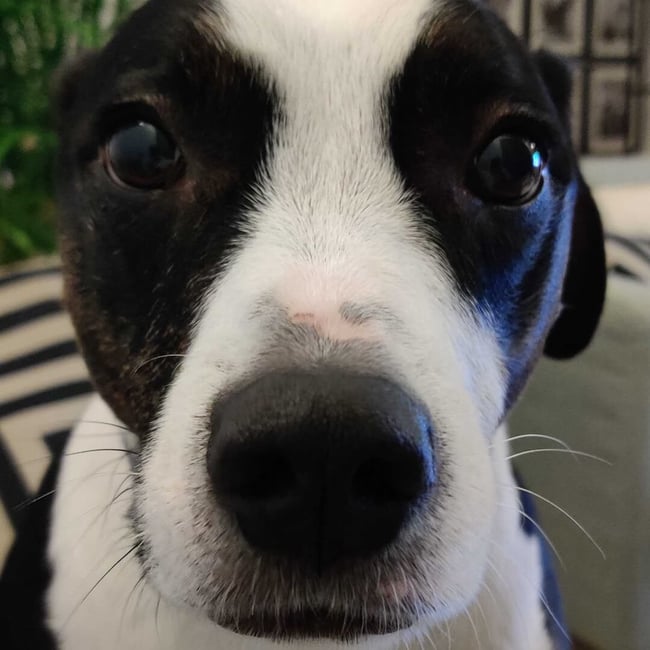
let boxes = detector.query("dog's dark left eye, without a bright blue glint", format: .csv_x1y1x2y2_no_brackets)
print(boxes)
105,122,182,190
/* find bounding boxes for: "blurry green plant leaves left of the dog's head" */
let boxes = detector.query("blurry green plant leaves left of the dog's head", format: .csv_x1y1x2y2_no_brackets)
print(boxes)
0,0,137,264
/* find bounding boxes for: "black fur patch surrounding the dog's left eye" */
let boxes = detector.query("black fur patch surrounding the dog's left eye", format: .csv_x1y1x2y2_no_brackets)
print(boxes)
58,0,276,436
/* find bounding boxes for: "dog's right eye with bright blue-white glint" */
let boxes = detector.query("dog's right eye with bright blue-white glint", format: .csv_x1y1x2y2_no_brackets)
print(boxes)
474,135,544,205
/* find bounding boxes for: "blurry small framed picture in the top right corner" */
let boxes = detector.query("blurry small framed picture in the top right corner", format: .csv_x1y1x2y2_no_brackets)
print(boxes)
593,0,637,57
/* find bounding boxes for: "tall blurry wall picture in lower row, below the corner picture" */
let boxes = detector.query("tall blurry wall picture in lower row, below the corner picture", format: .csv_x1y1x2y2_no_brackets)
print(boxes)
589,65,633,154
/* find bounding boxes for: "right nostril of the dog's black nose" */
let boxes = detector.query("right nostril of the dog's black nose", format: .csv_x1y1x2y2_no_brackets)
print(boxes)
351,448,429,506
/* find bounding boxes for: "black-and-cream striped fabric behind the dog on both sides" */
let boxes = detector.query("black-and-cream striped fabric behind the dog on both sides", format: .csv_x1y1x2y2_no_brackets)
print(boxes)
0,235,650,566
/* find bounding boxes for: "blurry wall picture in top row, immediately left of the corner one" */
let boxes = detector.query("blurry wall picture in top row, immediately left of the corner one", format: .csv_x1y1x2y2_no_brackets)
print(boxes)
531,0,586,56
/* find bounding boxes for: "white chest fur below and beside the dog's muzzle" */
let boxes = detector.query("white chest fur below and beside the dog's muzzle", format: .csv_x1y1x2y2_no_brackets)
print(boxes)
48,397,551,650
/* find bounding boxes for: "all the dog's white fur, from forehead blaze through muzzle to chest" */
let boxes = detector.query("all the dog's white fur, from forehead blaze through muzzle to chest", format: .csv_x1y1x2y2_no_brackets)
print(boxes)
49,0,547,650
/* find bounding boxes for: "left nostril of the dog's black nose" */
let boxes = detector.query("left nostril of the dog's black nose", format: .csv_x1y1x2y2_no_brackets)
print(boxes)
216,448,297,502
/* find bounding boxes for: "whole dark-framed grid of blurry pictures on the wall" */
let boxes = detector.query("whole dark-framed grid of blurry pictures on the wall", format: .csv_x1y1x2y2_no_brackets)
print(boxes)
484,0,650,155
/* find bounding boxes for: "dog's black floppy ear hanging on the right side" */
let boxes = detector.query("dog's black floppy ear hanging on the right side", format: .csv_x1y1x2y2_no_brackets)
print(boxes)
534,51,607,359
